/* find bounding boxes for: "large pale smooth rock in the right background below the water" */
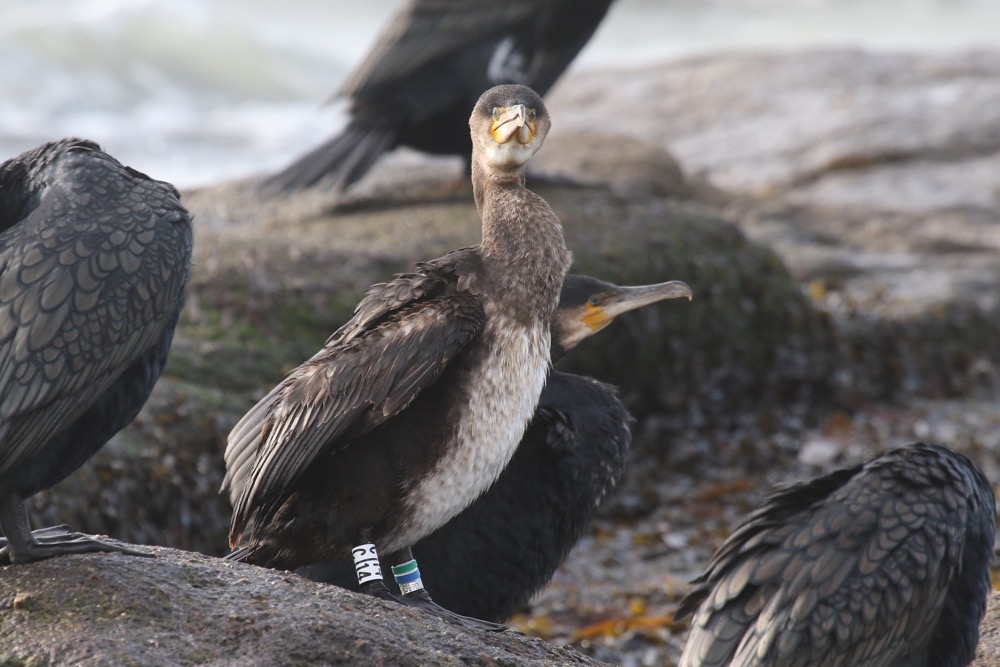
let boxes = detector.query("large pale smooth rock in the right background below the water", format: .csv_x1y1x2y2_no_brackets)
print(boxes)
547,50,1000,405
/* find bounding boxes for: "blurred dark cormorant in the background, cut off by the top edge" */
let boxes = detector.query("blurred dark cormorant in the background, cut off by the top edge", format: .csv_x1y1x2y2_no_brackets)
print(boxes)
264,0,611,191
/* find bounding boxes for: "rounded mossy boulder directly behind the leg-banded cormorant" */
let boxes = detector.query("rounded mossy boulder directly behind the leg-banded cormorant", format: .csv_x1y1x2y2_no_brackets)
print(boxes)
176,175,838,418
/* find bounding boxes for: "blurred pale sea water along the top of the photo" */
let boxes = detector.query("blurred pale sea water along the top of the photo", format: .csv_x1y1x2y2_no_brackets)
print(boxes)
0,0,1000,186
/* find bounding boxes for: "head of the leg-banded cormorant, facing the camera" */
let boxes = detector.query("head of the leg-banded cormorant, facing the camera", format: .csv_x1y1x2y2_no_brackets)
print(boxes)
469,85,552,171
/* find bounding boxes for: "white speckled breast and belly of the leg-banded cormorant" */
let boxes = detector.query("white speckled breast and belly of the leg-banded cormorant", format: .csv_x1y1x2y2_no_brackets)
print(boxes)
383,313,549,551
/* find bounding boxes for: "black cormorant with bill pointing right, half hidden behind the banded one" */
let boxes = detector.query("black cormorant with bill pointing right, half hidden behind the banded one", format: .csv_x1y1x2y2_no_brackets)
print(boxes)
296,275,691,622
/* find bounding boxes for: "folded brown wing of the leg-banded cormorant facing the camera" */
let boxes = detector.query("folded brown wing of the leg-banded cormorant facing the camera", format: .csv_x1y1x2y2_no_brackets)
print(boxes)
226,275,485,537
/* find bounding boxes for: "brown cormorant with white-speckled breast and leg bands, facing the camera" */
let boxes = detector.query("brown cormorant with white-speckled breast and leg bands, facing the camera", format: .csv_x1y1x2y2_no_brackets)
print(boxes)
223,85,571,628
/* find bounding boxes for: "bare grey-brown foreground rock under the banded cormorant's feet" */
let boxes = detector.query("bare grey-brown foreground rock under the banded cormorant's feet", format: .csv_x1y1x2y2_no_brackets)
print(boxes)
0,548,603,667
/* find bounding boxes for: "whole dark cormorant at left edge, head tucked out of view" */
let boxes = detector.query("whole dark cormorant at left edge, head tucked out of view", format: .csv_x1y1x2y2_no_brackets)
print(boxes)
0,139,191,563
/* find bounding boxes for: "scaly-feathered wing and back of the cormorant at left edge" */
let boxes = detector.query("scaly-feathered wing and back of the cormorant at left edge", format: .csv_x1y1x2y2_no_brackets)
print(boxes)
0,139,191,474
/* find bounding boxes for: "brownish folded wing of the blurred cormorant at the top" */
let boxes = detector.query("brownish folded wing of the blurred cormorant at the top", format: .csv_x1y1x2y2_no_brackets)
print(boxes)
335,0,540,97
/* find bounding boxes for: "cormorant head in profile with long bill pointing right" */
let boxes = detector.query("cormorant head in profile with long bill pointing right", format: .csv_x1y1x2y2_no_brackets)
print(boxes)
551,274,693,361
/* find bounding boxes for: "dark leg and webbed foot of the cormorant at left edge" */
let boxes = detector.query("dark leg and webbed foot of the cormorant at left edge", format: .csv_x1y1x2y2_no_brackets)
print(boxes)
0,492,153,563
